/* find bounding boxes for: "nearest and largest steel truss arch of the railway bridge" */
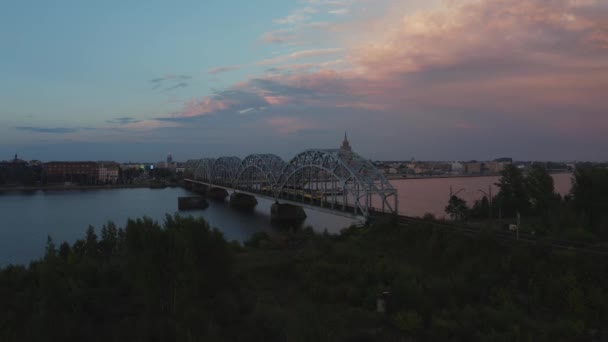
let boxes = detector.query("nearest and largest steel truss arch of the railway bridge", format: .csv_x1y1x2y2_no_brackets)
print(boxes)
276,149,398,217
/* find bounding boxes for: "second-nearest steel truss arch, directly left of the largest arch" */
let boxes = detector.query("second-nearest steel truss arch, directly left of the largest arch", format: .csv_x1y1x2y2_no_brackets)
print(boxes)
233,154,287,197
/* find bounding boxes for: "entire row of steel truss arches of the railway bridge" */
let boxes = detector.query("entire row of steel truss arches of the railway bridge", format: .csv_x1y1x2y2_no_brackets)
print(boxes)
185,149,398,218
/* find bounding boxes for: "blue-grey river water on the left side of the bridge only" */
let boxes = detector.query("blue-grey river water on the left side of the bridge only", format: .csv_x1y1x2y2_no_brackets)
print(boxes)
0,188,354,266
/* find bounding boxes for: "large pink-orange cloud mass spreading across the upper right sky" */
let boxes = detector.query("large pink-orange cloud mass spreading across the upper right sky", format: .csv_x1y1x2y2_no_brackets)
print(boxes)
166,0,608,142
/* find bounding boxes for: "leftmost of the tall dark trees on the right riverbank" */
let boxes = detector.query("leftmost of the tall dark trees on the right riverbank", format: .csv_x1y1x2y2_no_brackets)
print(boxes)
496,164,530,217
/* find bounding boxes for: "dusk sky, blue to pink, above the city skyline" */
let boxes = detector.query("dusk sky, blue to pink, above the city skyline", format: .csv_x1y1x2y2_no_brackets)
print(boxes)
0,0,608,161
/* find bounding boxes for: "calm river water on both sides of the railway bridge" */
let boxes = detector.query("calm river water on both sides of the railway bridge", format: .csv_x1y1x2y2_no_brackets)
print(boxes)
0,174,571,266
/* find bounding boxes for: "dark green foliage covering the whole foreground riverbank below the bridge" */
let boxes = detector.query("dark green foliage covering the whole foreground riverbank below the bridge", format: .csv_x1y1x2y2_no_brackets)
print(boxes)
0,216,608,342
